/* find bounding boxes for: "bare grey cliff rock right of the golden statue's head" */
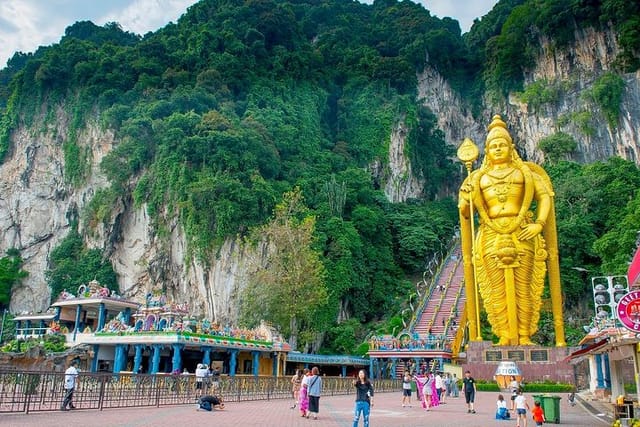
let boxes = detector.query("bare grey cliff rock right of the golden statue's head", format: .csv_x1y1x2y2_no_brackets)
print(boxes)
504,28,640,163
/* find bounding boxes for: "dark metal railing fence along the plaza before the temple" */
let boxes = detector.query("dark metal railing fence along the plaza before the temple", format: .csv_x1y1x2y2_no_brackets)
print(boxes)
0,372,401,413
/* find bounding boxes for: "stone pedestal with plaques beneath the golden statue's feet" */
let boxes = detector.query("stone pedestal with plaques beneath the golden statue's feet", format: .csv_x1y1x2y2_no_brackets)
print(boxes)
462,341,577,384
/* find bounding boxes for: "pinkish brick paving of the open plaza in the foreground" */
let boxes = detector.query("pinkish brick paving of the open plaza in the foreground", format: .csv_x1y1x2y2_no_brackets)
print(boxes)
0,392,610,427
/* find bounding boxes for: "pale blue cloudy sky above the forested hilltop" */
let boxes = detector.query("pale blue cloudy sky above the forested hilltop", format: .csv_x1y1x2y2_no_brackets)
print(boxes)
0,0,497,68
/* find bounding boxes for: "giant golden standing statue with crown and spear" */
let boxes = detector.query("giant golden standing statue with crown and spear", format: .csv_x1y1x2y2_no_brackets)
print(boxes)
458,115,566,347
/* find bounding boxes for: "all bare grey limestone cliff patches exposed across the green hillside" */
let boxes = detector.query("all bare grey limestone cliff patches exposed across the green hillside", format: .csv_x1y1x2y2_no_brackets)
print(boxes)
5,24,640,323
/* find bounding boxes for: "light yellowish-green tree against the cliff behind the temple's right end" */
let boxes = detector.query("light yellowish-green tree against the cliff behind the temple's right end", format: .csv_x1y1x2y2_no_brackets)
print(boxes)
242,188,327,349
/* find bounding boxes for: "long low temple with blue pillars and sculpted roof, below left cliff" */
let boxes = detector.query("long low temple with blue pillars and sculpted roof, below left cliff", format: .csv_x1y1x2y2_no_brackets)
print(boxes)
14,281,368,376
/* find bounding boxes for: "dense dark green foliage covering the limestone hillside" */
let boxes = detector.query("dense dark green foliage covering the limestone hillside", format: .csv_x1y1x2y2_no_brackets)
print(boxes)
0,0,640,352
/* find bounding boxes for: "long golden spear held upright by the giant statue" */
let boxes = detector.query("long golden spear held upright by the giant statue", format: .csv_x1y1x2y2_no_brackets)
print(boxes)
457,138,482,341
